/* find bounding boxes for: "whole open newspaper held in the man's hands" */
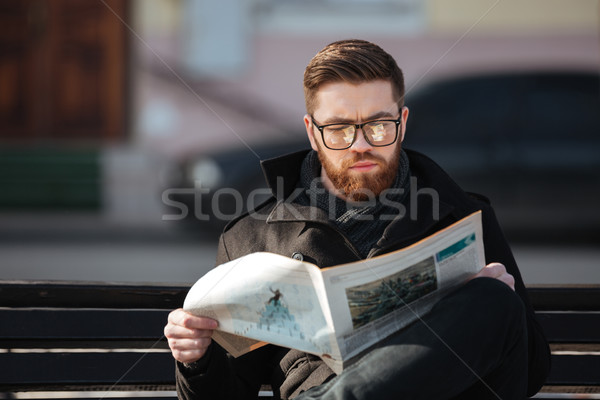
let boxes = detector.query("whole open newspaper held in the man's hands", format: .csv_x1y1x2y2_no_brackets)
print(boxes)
184,212,485,373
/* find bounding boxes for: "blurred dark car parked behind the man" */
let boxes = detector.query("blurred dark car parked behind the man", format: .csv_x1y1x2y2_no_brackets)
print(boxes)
166,72,600,243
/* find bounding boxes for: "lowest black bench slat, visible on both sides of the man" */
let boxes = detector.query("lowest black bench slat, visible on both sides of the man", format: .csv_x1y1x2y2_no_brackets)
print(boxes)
0,353,600,391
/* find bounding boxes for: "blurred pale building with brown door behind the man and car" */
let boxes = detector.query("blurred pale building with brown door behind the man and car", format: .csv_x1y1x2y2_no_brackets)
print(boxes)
0,0,600,282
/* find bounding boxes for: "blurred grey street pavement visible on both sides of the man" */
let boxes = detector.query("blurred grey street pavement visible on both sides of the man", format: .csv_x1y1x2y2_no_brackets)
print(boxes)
0,212,600,285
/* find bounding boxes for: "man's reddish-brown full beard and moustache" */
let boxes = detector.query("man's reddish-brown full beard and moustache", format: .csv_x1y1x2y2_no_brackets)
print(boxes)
317,143,401,201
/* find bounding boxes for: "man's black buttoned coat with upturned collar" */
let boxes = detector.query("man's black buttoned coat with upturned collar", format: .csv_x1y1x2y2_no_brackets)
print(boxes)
177,150,550,399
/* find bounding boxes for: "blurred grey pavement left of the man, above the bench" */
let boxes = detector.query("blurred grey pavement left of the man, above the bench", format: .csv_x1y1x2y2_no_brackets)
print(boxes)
0,213,218,283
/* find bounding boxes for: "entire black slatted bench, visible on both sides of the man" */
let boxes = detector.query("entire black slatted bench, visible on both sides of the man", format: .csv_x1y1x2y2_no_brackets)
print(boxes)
0,281,600,399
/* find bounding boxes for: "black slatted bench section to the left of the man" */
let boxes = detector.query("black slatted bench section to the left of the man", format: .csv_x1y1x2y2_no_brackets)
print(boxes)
0,282,183,397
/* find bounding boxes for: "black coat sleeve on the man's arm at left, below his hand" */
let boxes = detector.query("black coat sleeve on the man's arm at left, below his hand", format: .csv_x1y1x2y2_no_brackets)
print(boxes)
175,236,277,400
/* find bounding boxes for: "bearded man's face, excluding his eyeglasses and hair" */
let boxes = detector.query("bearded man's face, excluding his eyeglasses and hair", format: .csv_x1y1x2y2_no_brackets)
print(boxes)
304,80,408,201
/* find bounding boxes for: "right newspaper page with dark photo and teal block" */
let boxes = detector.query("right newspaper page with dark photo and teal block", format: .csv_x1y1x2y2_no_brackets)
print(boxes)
322,212,485,370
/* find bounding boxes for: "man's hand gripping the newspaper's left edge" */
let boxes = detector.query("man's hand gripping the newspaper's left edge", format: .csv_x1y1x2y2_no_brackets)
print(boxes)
165,308,218,363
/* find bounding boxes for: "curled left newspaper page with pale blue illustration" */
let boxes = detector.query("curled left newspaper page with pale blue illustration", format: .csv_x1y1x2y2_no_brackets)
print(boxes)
183,252,335,356
